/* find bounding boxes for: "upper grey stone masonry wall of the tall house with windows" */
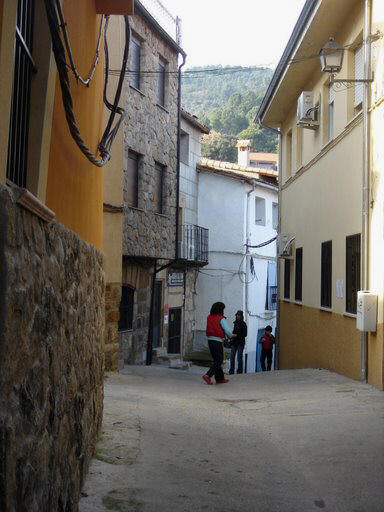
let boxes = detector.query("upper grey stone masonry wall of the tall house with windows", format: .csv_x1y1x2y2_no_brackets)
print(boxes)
123,15,178,259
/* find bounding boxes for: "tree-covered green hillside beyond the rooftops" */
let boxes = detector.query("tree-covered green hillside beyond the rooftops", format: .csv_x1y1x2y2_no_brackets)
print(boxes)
182,66,277,162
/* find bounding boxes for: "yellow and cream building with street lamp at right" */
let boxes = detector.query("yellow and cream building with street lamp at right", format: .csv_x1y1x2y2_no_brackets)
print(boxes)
258,0,384,389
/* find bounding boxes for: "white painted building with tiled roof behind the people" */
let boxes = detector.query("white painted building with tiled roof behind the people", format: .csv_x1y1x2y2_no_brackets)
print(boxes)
194,150,278,372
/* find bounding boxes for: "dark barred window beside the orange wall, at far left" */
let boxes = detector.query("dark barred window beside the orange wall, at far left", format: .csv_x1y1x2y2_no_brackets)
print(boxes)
7,0,36,187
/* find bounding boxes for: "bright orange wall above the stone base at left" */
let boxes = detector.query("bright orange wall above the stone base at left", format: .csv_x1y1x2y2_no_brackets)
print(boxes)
46,0,104,249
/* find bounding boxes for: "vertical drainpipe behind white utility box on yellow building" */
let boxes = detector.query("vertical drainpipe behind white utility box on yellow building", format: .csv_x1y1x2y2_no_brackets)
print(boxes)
360,0,371,382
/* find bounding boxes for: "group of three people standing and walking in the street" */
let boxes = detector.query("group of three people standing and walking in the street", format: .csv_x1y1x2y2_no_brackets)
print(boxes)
203,302,275,384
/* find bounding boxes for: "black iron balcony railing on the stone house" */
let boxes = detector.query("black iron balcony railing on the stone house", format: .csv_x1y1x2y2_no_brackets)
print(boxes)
179,224,208,263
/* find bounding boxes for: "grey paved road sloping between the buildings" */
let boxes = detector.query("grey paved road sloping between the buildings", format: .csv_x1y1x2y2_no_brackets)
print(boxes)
80,367,384,512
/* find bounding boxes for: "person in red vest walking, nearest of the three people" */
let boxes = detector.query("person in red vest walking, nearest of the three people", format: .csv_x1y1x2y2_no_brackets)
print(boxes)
202,302,232,384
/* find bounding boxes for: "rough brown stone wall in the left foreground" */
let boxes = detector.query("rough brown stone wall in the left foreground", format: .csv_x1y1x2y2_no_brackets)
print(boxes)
0,187,104,512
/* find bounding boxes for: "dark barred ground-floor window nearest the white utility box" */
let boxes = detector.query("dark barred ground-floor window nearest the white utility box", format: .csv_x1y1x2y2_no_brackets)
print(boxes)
345,234,360,314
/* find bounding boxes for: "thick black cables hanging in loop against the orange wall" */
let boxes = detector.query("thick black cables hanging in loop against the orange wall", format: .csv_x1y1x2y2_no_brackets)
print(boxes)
45,0,131,167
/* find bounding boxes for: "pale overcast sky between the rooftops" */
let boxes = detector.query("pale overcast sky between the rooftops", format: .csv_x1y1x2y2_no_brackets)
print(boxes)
161,0,305,67
